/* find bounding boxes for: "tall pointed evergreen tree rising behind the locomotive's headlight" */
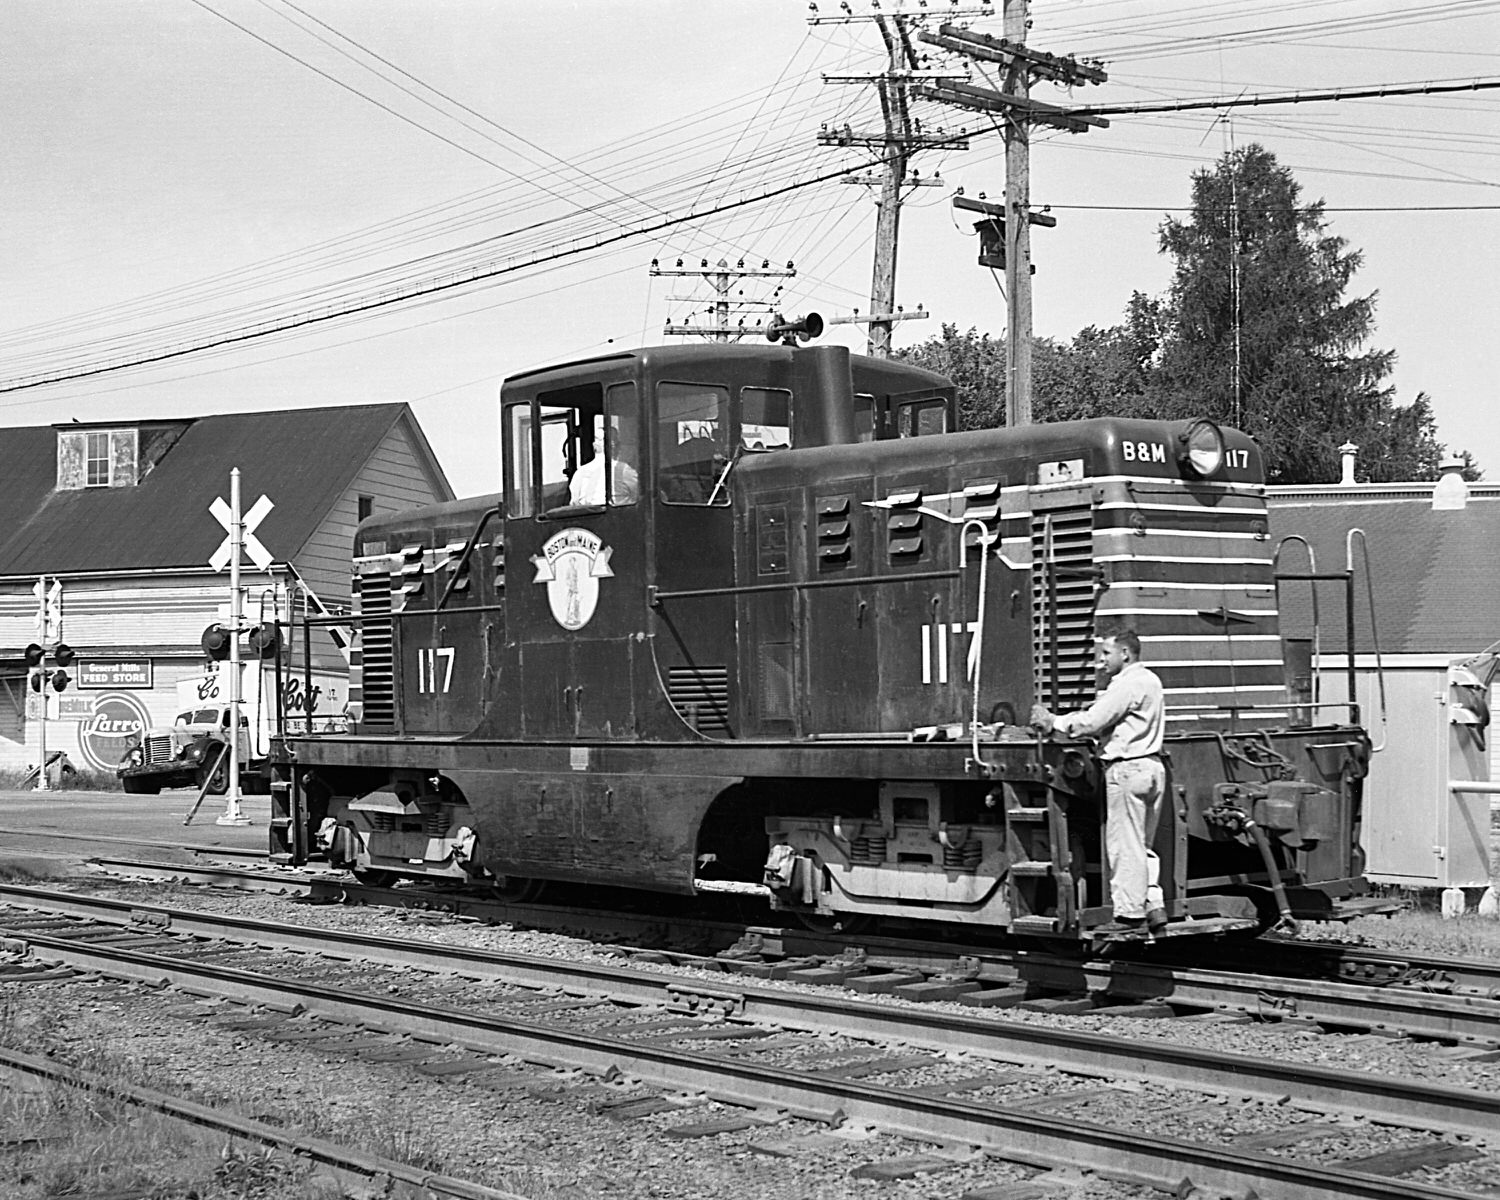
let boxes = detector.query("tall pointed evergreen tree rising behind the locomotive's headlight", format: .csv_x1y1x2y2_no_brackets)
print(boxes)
1152,146,1443,483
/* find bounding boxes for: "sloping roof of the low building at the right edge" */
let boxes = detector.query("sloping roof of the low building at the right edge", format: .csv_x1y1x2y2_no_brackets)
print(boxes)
1268,485,1500,656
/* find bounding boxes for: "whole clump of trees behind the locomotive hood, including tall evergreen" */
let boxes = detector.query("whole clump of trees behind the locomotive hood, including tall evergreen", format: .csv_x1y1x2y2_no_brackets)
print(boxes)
903,146,1478,483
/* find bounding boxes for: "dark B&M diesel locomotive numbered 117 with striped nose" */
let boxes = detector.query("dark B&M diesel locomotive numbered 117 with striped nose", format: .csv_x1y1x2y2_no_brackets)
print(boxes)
272,336,1370,941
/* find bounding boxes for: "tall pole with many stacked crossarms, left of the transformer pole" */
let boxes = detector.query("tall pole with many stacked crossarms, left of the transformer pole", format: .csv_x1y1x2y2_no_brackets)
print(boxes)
809,3,995,359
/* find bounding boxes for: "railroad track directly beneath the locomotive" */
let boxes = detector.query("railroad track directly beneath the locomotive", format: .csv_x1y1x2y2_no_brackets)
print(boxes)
85,860,1500,1047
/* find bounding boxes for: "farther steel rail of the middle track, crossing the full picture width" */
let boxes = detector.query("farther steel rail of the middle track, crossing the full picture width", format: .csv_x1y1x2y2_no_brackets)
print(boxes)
0,887,1500,1140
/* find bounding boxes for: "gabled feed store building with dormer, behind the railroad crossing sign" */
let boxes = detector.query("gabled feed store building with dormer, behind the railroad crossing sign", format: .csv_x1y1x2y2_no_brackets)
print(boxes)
0,404,453,770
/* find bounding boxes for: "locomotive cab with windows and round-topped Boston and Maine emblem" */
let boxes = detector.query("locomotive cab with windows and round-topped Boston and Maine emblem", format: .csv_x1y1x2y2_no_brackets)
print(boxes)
489,347,954,740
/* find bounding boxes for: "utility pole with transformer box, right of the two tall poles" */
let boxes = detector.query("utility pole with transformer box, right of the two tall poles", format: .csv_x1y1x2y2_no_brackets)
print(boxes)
915,0,1109,426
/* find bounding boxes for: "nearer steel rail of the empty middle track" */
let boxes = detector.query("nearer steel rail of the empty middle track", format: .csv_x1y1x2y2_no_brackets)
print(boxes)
0,936,1493,1200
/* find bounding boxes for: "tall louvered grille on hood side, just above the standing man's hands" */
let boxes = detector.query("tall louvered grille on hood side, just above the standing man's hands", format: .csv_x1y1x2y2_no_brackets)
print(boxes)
1032,506,1098,711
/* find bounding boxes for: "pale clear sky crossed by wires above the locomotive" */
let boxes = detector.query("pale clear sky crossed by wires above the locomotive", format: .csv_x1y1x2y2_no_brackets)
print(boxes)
0,0,1500,498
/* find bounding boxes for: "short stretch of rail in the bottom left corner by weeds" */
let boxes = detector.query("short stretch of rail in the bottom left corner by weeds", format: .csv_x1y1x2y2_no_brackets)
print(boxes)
0,1047,525,1200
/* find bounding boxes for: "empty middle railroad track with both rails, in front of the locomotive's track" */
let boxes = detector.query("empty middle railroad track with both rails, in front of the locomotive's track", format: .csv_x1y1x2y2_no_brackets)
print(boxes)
0,888,1500,1200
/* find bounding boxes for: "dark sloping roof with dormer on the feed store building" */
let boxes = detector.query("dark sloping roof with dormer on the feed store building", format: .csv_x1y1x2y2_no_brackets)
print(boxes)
0,404,452,576
